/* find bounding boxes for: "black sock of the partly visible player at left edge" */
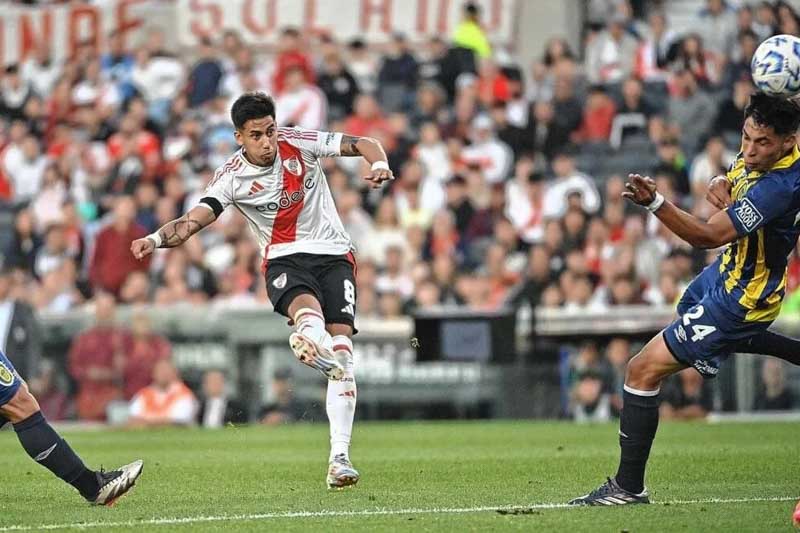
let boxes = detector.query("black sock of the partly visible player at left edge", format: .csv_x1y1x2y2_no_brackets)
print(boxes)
14,411,100,499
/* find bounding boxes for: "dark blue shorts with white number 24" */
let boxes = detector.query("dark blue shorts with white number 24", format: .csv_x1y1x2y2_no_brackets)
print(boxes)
664,262,771,378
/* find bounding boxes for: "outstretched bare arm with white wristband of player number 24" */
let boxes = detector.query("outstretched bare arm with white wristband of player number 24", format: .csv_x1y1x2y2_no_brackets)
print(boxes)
622,174,738,248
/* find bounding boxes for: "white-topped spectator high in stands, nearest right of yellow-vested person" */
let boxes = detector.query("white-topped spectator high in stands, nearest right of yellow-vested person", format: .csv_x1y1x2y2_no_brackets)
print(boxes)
586,14,638,84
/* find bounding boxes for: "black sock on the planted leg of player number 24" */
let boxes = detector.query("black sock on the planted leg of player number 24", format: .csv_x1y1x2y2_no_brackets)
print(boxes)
616,389,660,494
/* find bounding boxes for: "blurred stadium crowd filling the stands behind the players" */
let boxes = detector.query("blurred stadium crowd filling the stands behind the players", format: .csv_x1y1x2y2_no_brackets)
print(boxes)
0,0,800,420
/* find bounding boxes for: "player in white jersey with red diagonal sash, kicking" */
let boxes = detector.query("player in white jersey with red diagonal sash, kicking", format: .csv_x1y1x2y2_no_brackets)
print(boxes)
131,92,393,488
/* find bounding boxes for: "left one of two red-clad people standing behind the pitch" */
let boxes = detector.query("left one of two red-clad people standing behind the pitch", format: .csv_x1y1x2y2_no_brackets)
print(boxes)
67,292,132,421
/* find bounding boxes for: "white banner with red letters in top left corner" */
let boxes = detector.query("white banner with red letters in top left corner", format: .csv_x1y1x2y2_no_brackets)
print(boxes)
0,0,159,65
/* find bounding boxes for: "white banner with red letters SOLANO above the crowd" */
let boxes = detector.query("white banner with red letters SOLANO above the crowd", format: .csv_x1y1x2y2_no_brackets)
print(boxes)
177,0,517,46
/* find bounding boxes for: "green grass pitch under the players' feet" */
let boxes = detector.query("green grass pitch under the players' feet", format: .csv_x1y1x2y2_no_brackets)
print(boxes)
0,422,800,532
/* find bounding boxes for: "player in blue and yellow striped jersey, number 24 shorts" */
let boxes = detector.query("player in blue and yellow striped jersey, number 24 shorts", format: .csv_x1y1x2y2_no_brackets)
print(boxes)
570,94,800,506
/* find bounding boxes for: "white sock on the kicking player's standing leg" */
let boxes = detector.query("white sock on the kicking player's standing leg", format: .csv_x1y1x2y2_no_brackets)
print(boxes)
325,335,356,460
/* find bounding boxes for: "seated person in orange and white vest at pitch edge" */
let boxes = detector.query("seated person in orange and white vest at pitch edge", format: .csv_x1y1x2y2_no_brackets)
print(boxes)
128,359,197,427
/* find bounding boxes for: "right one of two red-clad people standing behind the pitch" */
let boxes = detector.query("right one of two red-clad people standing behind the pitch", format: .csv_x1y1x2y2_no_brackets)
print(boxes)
124,311,172,401
